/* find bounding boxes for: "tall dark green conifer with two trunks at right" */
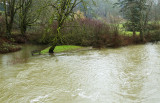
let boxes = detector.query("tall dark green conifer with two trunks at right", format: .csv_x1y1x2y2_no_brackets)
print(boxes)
117,0,152,41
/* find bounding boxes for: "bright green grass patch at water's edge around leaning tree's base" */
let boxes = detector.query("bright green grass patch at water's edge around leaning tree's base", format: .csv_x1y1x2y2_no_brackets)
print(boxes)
41,45,83,54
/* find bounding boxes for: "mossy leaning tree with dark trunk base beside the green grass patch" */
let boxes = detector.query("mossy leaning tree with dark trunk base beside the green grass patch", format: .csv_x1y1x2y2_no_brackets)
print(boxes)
42,0,89,53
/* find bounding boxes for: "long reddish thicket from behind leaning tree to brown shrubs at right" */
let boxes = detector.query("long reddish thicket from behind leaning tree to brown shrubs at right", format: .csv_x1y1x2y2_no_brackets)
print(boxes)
38,18,130,48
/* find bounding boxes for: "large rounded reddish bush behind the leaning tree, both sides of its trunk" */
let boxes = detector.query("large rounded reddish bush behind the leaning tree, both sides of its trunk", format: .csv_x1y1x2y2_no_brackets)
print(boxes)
41,18,111,47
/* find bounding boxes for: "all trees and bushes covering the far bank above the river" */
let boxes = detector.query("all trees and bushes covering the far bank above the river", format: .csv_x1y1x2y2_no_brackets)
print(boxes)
0,0,160,52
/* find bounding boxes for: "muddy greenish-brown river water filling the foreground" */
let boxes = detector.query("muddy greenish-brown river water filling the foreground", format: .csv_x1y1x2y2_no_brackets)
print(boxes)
0,43,160,103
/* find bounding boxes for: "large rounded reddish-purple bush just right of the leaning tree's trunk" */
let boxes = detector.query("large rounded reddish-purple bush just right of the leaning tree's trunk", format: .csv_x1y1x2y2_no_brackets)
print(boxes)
62,18,111,47
